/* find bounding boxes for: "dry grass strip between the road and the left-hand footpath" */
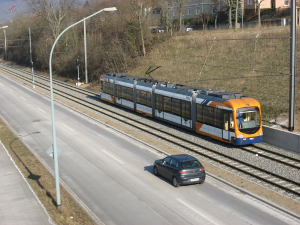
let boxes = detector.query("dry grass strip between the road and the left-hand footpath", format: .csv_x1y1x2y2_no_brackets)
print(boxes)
0,120,94,225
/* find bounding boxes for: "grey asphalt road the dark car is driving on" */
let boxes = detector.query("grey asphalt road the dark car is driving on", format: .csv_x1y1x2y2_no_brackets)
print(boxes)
0,73,299,225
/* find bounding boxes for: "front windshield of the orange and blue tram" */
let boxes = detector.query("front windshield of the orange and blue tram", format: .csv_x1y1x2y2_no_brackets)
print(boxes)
236,107,260,134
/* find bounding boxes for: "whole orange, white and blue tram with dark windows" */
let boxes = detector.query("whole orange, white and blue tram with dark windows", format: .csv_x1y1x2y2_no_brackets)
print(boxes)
100,73,263,145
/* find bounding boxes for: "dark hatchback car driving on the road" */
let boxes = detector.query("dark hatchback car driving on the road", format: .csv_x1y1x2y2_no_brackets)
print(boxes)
153,154,205,187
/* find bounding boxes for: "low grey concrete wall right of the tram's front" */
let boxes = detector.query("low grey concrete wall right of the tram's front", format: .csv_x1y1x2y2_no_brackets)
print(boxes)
263,126,300,153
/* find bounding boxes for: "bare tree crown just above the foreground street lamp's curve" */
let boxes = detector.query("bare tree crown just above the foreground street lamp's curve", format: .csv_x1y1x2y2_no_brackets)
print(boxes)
24,0,76,39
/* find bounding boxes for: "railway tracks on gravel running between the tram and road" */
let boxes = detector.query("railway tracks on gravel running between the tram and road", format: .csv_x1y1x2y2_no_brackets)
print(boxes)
0,60,300,201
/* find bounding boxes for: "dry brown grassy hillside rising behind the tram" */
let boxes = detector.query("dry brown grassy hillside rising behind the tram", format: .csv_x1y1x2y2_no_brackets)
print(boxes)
128,27,300,132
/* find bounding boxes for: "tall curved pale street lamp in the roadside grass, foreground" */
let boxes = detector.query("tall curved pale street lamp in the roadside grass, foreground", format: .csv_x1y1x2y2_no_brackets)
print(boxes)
49,7,117,209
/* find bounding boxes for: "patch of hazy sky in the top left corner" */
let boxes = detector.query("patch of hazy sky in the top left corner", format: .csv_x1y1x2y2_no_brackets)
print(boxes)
0,0,26,23
